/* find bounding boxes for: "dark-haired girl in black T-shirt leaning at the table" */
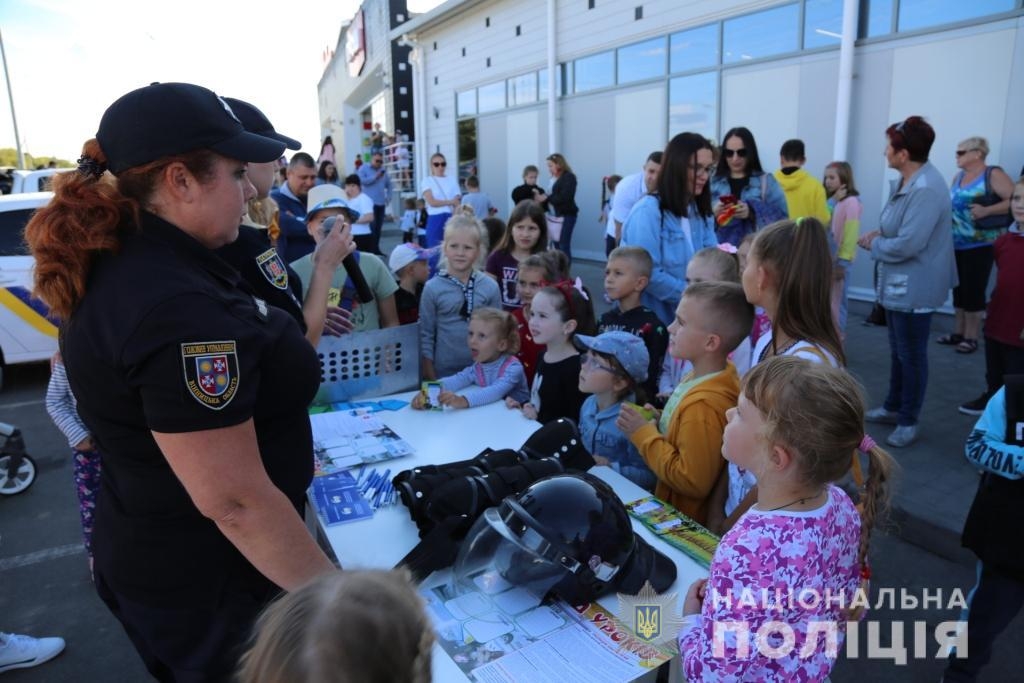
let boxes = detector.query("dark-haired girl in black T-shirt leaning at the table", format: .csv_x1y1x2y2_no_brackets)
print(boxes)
506,279,597,424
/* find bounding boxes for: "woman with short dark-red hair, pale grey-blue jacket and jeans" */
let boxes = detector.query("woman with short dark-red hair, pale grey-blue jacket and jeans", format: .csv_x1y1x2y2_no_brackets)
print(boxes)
857,116,956,447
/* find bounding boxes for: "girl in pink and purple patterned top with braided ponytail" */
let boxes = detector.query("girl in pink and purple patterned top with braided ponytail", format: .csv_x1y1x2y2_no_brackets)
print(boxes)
679,356,892,681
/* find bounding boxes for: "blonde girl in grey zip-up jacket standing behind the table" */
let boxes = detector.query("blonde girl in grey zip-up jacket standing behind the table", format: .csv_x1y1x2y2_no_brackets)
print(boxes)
420,214,502,380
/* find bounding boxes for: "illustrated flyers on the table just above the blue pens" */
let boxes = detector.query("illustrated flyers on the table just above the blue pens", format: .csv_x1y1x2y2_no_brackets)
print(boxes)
309,410,413,476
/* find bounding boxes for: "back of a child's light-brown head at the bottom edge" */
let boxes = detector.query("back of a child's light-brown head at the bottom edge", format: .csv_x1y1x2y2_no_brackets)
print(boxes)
238,569,434,683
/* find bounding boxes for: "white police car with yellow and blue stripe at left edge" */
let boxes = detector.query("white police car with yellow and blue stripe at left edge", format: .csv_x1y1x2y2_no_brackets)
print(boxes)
0,193,57,388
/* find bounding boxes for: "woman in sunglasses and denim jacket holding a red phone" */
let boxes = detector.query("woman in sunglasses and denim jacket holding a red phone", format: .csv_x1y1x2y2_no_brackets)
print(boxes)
711,126,790,247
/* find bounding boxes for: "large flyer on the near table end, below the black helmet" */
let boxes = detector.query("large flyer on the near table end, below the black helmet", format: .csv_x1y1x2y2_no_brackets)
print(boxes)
422,577,678,683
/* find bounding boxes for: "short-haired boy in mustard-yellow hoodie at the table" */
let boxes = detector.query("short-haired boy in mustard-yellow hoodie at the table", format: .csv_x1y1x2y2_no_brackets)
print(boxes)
615,282,754,524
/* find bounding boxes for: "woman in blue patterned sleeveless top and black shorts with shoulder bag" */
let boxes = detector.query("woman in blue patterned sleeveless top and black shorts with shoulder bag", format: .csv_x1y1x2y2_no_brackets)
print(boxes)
938,137,1014,353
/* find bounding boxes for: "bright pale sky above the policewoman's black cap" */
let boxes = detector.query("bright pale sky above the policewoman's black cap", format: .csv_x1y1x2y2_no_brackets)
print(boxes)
0,0,438,160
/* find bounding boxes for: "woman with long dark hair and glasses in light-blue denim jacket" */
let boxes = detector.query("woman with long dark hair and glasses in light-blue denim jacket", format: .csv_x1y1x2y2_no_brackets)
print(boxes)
622,133,718,325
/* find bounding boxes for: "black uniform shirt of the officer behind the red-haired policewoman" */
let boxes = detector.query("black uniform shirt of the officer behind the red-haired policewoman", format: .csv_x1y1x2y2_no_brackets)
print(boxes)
217,225,306,334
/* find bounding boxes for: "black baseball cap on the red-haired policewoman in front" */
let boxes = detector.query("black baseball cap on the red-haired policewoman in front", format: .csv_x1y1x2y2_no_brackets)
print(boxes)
96,83,285,175
